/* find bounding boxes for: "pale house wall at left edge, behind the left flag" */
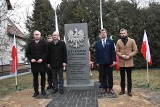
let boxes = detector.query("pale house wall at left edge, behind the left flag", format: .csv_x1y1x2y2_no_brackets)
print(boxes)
0,0,25,65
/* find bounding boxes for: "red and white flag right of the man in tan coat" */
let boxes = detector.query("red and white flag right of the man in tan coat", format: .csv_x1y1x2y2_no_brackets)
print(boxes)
141,31,152,65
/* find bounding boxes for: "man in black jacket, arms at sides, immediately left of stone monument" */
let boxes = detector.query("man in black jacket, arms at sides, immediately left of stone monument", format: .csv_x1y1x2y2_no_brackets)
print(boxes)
47,32,67,94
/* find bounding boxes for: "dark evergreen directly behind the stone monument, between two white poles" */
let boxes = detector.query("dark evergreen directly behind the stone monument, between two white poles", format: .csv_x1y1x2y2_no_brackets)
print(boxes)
57,0,100,43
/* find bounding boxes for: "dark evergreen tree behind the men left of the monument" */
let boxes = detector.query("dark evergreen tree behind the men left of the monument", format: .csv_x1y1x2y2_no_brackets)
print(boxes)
26,0,55,40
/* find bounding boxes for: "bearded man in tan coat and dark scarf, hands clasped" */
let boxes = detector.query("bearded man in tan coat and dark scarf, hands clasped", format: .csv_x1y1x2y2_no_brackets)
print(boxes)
116,29,138,96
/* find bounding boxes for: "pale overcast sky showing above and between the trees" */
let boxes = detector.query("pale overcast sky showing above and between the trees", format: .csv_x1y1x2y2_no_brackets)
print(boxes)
10,0,160,32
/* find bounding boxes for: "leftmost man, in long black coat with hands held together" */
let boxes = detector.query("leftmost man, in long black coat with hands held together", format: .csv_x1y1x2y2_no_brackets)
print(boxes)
26,30,48,97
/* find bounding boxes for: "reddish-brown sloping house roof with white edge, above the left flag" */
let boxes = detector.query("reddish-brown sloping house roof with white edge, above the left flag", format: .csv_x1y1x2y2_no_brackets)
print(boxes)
7,18,24,39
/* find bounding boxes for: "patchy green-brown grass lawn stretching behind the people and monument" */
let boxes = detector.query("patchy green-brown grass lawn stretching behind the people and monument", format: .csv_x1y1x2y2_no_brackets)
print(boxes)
0,69,160,97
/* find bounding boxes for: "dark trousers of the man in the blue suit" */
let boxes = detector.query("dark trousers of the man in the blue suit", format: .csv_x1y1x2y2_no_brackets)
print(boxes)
99,64,113,89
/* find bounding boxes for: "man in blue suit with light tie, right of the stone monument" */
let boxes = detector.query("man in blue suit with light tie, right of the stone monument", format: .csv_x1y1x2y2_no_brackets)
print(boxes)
95,29,116,94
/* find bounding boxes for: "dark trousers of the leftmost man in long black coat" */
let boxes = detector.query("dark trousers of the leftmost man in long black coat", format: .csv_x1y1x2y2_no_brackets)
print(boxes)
32,72,46,93
